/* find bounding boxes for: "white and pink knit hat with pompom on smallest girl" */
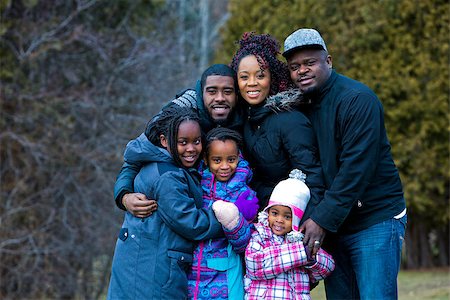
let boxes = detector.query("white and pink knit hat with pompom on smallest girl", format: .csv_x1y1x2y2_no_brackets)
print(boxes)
264,169,311,231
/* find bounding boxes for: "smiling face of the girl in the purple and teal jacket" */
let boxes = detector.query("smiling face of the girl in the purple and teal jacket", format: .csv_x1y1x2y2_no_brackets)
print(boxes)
205,140,239,182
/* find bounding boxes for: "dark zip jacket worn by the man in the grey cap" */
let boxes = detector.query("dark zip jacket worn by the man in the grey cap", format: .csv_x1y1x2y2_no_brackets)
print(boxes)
304,71,405,233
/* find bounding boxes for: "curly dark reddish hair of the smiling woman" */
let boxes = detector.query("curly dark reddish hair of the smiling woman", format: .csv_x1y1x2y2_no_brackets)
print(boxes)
230,31,293,95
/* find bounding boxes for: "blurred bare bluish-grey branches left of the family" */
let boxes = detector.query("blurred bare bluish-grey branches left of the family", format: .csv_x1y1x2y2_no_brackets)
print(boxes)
0,0,226,299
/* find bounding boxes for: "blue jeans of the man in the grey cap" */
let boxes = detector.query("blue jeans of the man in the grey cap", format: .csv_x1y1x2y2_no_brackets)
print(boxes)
325,215,407,300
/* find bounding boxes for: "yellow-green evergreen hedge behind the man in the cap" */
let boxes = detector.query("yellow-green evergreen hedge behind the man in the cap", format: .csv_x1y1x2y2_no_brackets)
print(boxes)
217,0,450,268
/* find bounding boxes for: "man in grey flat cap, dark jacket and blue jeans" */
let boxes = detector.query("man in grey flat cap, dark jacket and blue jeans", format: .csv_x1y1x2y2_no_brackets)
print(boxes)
283,29,407,299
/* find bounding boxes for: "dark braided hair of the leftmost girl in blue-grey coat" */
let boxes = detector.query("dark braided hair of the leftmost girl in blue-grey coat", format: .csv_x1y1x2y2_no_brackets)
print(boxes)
145,105,200,166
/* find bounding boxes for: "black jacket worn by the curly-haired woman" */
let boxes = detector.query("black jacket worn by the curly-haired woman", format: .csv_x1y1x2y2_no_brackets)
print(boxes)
244,102,324,220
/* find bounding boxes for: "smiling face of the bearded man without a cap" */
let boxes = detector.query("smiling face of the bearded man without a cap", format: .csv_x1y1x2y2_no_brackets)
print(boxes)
203,75,236,122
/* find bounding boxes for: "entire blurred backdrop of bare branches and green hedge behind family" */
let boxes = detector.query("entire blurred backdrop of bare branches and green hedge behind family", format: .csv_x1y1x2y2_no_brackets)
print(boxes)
0,0,450,299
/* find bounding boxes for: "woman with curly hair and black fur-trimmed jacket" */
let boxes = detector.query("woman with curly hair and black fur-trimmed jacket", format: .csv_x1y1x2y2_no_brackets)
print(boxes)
231,32,324,226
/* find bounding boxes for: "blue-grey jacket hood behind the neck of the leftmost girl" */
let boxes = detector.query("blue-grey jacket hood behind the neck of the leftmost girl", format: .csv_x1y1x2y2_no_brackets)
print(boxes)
124,133,173,164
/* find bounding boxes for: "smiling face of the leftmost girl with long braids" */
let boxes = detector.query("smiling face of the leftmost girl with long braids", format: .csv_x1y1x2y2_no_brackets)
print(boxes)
160,121,202,168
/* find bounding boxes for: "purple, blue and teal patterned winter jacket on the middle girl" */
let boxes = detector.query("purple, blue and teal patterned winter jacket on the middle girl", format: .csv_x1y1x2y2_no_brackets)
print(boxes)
188,156,258,299
